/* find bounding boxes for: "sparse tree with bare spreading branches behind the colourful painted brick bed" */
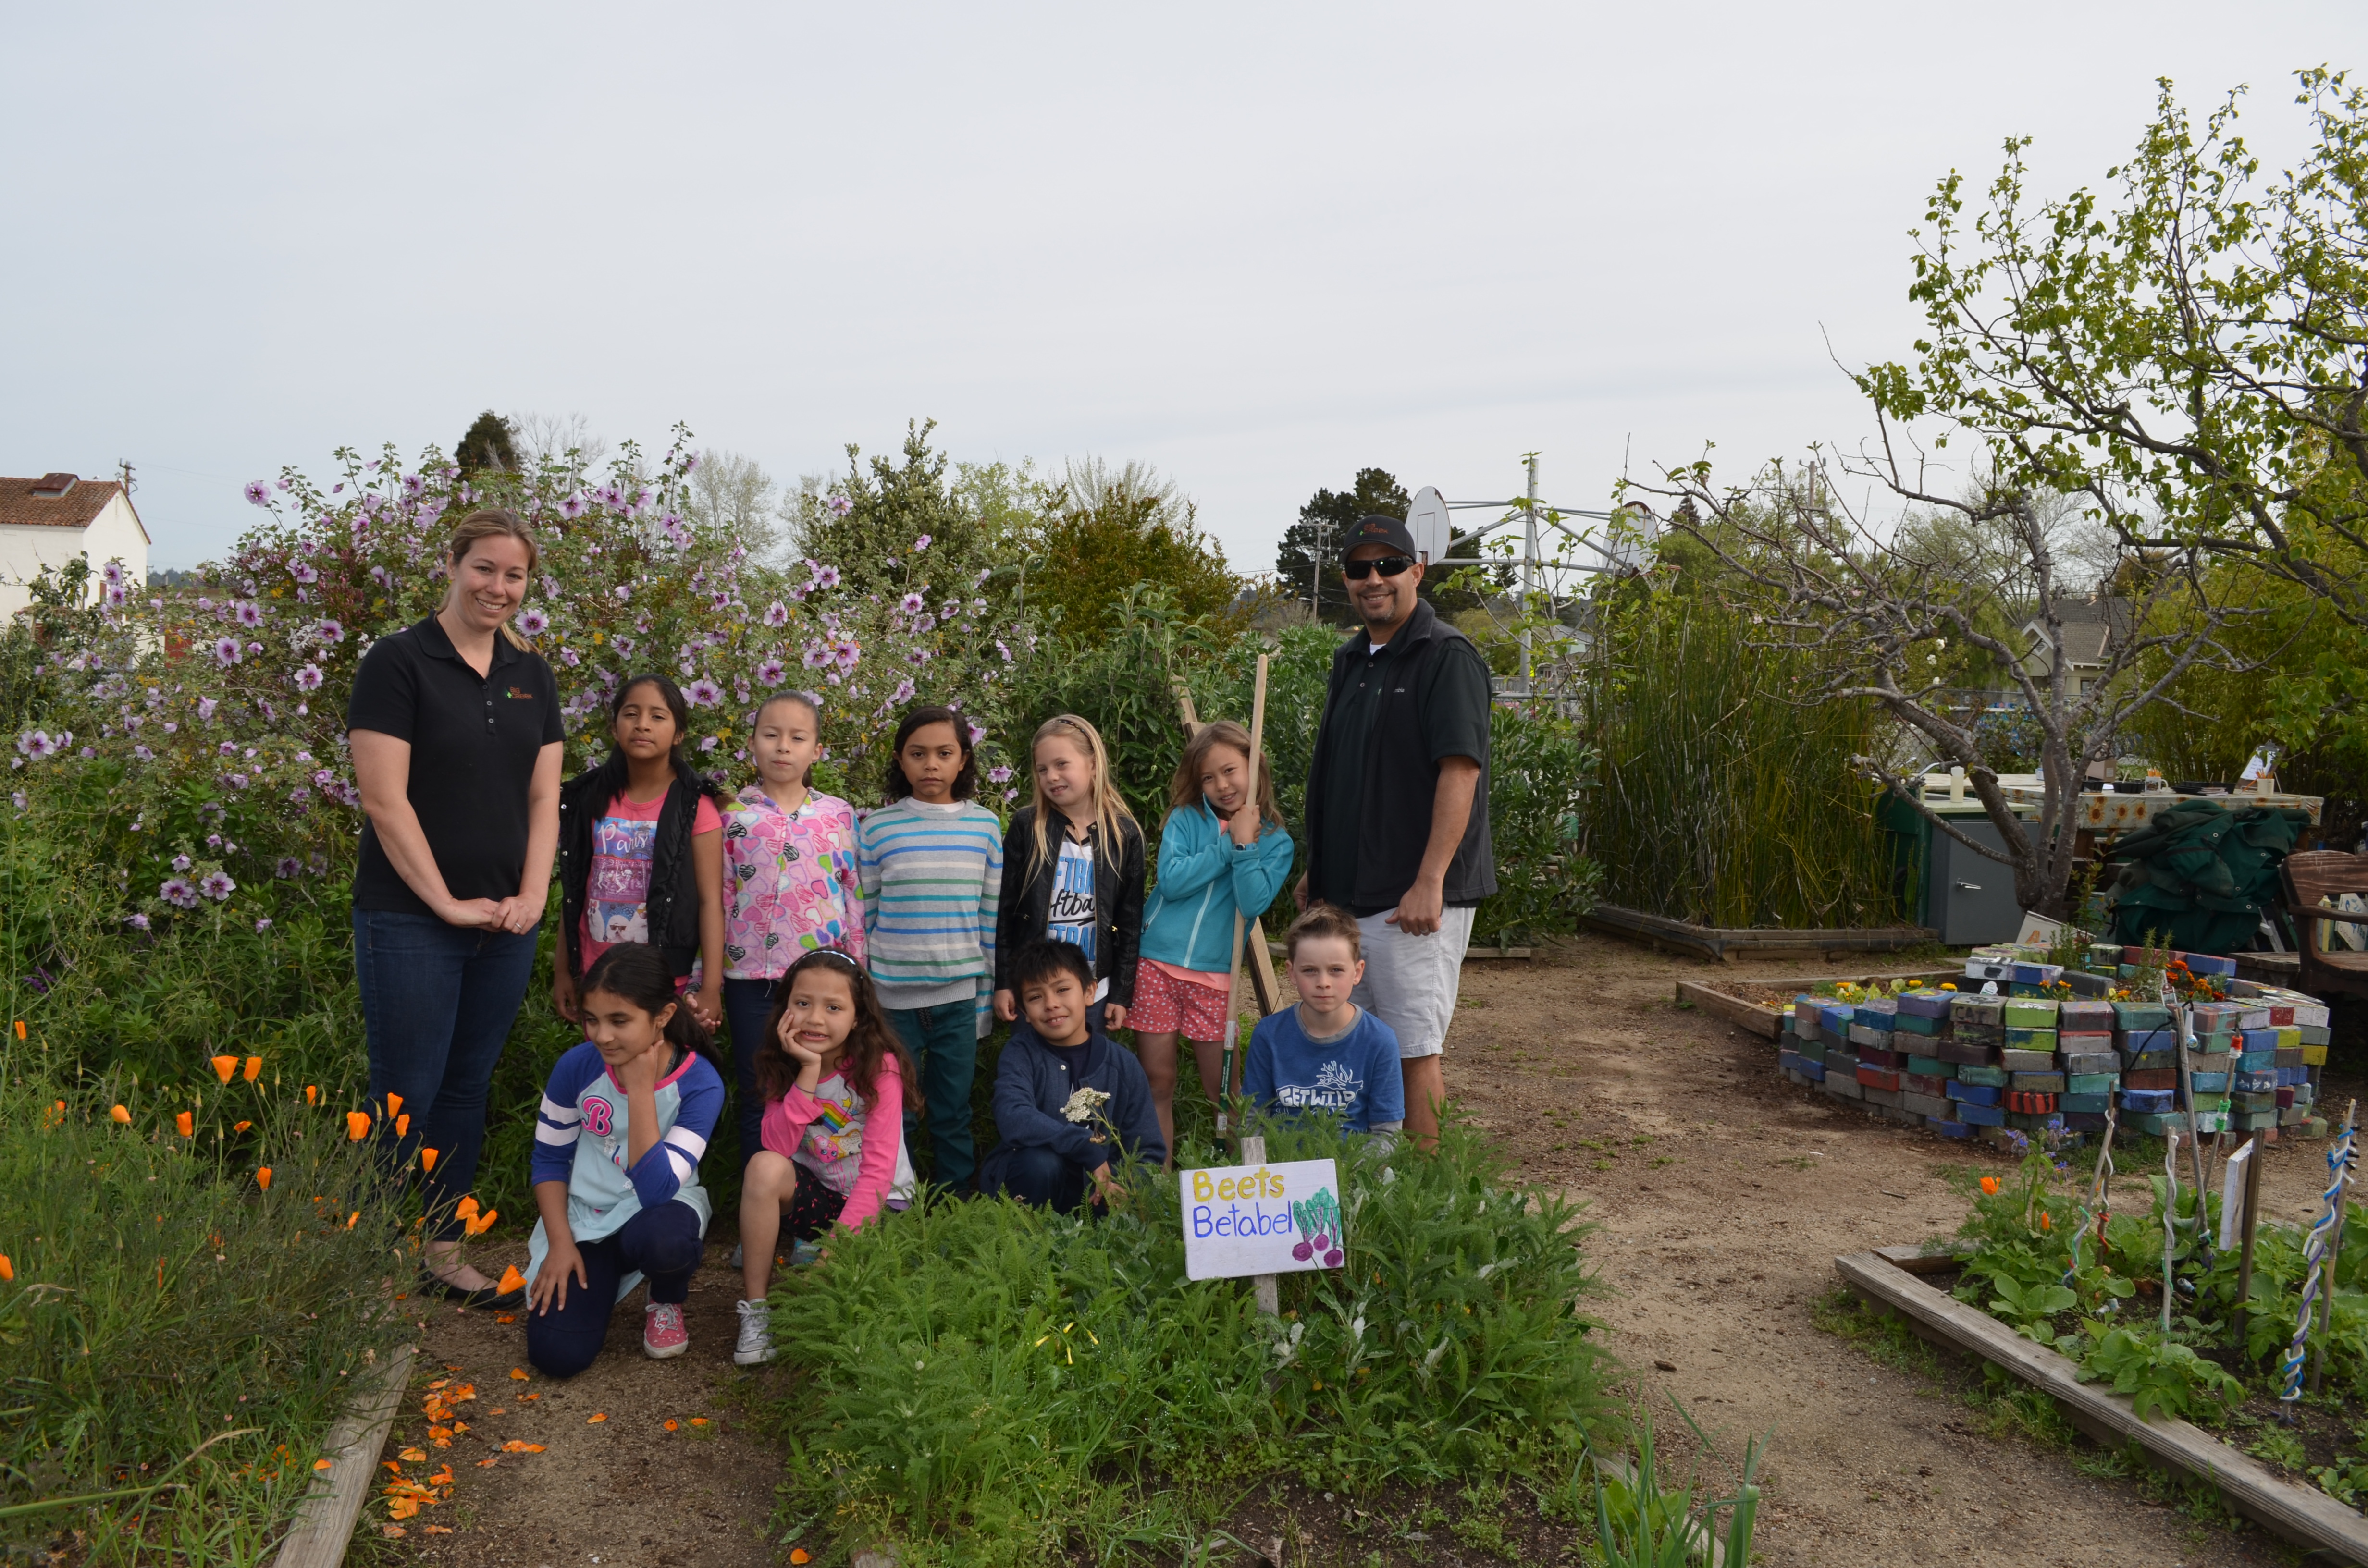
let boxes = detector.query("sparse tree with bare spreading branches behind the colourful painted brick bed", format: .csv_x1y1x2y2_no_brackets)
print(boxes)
1631,462,2252,914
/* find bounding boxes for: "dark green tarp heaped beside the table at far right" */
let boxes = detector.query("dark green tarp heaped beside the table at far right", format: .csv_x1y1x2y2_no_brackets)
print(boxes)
2105,801,2311,955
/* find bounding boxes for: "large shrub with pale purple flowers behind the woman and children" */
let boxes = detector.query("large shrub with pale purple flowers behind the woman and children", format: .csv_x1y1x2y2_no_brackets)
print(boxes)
10,431,1028,929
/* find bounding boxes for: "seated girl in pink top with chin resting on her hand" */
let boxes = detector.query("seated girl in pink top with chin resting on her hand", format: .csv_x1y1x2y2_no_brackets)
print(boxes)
732,947,921,1367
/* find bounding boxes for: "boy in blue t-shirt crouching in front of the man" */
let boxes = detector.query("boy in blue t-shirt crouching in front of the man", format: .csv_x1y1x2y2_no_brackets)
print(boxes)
1241,905,1406,1142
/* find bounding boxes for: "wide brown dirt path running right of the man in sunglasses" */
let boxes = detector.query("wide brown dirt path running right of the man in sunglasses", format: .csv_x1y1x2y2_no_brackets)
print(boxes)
1449,943,2352,1568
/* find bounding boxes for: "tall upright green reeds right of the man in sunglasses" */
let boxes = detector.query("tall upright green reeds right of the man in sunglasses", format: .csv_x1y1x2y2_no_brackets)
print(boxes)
1582,588,1901,929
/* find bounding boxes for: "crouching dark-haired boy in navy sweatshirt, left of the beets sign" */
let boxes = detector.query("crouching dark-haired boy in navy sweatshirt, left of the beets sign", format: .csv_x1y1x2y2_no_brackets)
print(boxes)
978,940,1168,1215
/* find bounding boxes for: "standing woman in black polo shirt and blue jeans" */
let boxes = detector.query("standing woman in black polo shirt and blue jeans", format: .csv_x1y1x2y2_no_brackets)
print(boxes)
345,507,564,1305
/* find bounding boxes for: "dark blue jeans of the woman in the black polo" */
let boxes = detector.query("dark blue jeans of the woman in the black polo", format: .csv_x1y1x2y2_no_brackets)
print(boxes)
353,909,535,1241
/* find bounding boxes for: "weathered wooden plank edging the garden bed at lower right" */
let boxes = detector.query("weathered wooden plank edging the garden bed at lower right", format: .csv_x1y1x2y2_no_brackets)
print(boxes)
1833,1248,2368,1568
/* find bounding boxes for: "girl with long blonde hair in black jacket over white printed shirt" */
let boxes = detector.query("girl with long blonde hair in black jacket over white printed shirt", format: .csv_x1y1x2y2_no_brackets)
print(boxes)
995,713,1144,1028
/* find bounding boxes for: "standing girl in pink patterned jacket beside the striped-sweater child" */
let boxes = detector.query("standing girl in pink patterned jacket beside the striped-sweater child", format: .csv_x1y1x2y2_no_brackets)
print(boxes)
725,694,864,1163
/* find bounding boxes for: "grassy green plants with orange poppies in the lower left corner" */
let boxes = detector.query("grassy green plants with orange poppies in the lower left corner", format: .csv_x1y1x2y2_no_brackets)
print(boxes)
0,1028,412,1563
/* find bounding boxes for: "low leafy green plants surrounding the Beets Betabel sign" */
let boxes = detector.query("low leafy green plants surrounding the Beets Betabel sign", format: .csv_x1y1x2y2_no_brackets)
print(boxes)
774,1125,1617,1563
